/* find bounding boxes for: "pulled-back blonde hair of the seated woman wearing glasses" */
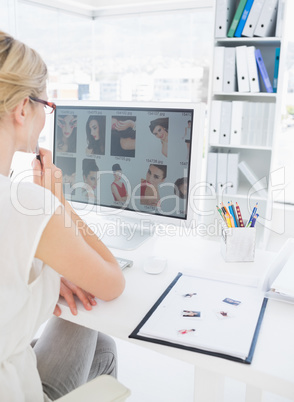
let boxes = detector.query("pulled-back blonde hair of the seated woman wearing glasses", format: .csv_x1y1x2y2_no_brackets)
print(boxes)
0,31,48,119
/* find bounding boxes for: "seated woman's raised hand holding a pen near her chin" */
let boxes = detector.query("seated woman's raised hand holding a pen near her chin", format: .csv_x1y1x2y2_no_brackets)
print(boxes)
32,148,65,204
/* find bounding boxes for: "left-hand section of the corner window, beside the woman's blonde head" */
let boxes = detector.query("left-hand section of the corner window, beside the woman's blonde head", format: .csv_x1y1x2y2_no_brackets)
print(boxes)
17,1,93,99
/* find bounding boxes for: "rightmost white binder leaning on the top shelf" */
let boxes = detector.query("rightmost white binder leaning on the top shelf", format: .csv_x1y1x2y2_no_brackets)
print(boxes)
254,0,278,37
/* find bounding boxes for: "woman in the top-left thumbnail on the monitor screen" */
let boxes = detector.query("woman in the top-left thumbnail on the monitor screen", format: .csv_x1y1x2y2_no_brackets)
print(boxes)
57,115,77,153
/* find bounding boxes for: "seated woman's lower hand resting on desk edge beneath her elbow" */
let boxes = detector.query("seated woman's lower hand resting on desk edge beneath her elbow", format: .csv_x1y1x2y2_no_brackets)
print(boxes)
54,277,97,317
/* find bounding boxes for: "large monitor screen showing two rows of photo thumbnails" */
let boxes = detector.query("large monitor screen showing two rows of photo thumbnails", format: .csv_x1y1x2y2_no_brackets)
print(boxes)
54,104,202,226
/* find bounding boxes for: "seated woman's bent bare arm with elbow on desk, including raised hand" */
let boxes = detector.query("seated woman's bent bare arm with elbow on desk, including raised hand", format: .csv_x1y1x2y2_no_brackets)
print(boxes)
34,149,125,300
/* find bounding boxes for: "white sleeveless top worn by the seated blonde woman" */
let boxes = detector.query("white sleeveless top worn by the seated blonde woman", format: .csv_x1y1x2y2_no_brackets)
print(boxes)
0,175,60,402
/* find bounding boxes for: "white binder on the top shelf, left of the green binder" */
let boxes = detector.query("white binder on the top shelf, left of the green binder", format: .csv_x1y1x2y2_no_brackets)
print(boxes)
214,0,236,38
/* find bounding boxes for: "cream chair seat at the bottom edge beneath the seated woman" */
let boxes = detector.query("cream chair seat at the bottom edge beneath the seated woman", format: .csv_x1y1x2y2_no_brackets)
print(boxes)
58,375,131,402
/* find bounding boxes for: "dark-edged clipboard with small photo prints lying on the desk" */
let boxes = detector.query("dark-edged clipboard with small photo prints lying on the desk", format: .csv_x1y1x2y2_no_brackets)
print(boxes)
129,272,267,364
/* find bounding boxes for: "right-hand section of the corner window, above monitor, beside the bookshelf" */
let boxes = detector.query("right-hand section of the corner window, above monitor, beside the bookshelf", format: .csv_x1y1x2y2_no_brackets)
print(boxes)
94,9,213,102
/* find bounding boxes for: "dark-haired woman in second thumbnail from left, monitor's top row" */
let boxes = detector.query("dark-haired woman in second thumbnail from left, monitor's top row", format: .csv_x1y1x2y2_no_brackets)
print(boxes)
86,115,105,155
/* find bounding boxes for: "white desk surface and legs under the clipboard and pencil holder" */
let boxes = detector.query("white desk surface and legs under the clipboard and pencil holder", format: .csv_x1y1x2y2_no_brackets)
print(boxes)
61,232,294,402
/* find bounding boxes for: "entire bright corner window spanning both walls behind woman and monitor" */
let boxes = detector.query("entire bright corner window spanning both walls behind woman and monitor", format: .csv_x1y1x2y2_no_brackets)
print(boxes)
17,1,213,102
